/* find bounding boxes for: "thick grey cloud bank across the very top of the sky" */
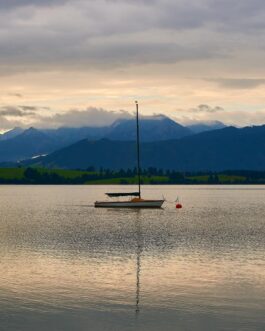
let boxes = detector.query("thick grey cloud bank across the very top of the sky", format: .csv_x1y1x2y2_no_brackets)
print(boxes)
0,0,265,74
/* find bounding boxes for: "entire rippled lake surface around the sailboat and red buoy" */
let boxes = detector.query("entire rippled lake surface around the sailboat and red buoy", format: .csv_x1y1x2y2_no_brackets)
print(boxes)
0,186,265,331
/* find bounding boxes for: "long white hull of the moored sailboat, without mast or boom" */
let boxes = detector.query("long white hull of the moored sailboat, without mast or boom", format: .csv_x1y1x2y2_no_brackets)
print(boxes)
95,200,165,208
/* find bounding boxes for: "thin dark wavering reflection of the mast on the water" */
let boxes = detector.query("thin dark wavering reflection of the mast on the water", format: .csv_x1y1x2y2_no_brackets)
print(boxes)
135,213,143,316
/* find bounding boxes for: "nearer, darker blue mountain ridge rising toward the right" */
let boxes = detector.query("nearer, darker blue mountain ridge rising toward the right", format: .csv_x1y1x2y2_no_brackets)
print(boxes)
23,125,265,171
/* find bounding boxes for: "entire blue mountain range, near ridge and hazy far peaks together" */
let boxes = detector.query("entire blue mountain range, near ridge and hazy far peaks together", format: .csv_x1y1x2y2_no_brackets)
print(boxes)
0,116,265,171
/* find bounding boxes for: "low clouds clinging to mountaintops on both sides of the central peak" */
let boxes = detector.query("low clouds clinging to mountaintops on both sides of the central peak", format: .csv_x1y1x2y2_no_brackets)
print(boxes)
0,104,265,131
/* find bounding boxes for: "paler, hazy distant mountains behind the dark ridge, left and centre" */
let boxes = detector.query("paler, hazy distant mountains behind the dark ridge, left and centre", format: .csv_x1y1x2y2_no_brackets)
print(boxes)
0,115,209,162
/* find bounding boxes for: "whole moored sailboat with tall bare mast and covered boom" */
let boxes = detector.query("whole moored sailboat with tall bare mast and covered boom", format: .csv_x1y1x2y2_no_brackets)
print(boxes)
95,101,165,208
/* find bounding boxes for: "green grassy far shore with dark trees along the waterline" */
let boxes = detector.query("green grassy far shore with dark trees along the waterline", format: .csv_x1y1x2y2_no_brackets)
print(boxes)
0,168,265,185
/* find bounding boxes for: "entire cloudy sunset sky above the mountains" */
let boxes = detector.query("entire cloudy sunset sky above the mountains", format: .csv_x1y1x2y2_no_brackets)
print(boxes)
0,0,265,131
